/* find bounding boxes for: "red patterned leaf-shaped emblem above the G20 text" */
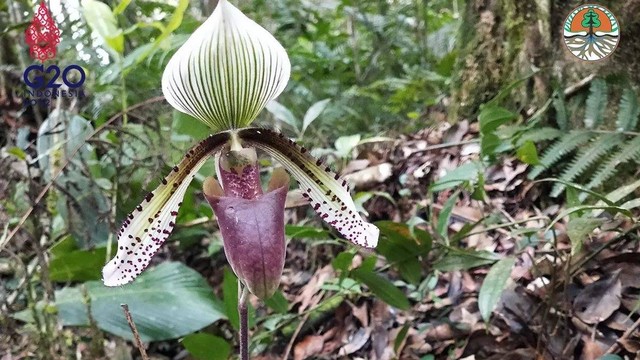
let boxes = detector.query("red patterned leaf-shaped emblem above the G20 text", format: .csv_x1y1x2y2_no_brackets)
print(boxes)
25,1,60,62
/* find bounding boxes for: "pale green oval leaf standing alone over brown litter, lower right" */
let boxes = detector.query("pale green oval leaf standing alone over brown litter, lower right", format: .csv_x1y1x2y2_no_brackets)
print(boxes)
478,257,516,322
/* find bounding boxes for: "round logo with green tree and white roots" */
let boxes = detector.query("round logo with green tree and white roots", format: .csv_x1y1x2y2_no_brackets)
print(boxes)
564,4,620,61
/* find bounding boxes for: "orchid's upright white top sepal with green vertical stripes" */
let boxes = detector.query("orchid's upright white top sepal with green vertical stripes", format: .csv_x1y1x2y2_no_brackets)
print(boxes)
162,0,291,131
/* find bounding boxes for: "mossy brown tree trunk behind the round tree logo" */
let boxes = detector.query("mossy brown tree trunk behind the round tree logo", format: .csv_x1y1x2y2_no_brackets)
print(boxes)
449,0,640,121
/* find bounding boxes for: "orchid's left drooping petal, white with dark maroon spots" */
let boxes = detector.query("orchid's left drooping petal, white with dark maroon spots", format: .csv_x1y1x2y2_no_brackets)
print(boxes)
102,132,229,286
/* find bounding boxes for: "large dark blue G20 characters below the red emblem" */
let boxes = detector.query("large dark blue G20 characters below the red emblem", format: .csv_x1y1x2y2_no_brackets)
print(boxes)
22,64,87,89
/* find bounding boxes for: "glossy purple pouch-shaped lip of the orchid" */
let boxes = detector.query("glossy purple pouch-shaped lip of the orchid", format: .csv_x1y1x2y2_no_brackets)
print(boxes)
203,165,289,299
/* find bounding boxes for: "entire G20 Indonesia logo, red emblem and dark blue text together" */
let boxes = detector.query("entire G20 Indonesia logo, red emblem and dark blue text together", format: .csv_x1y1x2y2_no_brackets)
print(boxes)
21,1,86,107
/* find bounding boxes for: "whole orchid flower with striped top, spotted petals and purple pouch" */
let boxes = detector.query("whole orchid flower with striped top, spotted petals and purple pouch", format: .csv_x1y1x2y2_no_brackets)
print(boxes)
102,0,379,298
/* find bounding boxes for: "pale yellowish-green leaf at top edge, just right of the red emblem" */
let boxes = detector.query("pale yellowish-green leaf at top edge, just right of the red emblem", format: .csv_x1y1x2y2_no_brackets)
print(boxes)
82,0,124,54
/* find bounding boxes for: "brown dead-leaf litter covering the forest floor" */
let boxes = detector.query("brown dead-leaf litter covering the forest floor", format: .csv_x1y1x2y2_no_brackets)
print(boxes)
0,115,640,360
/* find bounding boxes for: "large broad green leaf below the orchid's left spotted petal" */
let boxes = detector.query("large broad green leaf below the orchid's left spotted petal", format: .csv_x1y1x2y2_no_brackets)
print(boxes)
55,262,225,342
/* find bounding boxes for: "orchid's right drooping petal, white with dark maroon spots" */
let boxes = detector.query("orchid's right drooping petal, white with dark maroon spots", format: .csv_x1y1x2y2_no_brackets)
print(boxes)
238,128,380,248
